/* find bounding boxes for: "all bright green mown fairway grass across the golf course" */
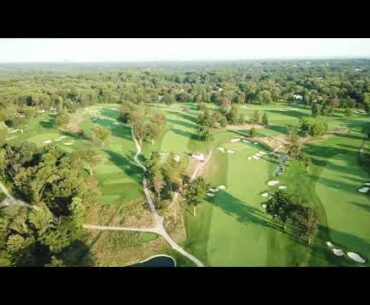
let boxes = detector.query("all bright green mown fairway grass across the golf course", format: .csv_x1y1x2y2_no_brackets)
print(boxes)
4,103,370,266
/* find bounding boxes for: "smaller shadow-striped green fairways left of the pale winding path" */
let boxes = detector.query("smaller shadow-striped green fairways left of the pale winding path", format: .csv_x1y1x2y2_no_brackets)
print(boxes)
8,104,144,204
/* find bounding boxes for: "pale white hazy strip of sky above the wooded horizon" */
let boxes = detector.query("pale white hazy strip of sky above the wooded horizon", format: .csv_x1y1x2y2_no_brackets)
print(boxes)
0,38,370,63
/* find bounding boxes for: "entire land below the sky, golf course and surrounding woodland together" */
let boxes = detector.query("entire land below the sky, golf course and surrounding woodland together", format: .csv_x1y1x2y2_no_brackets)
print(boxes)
0,59,370,267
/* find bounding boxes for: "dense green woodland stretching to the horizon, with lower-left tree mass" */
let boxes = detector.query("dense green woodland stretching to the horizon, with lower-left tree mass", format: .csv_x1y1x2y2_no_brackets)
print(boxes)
0,60,370,266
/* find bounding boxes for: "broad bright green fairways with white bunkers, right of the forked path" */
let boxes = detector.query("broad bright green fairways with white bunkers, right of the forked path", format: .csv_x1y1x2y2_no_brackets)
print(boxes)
185,105,370,266
